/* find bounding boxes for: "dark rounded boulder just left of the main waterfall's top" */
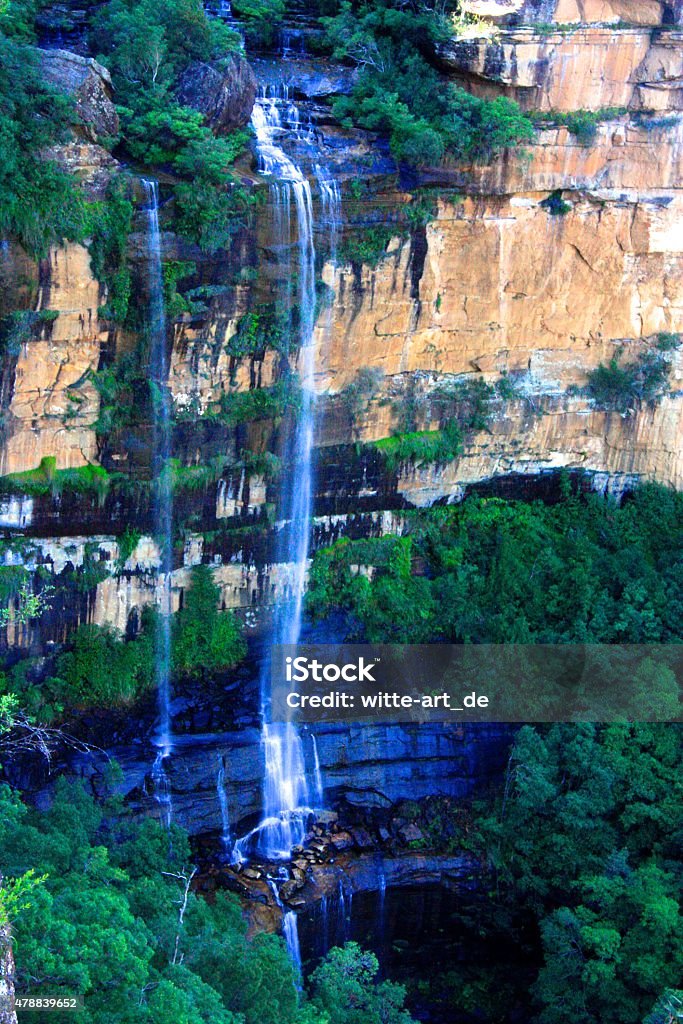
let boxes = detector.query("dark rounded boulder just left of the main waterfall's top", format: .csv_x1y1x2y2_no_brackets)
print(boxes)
177,54,256,135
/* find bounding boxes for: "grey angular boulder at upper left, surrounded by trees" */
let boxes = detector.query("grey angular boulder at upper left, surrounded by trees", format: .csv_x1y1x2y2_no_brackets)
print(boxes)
39,50,119,142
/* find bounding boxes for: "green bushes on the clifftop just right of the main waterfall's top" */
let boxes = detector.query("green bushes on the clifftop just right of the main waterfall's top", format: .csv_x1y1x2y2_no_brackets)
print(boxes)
322,0,533,167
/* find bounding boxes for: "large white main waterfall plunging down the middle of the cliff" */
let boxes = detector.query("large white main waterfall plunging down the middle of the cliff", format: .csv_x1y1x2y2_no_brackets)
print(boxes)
234,86,339,862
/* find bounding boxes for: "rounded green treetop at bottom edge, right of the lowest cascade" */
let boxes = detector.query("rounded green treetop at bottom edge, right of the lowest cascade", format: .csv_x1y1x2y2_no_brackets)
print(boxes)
310,942,414,1024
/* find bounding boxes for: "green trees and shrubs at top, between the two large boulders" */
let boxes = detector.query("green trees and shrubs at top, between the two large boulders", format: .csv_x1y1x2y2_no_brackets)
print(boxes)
91,0,250,252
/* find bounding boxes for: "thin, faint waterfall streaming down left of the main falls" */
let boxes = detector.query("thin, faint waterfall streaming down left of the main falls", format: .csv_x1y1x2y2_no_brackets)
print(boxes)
142,178,173,823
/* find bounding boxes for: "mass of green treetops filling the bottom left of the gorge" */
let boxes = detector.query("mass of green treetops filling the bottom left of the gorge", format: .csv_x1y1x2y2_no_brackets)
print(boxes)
0,770,412,1024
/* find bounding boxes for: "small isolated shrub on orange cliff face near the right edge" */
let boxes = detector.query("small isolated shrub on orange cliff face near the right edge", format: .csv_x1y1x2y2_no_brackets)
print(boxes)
587,351,671,413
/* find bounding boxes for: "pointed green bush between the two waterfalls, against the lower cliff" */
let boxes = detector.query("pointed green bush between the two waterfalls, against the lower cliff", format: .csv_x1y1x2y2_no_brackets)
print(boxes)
172,565,246,679
